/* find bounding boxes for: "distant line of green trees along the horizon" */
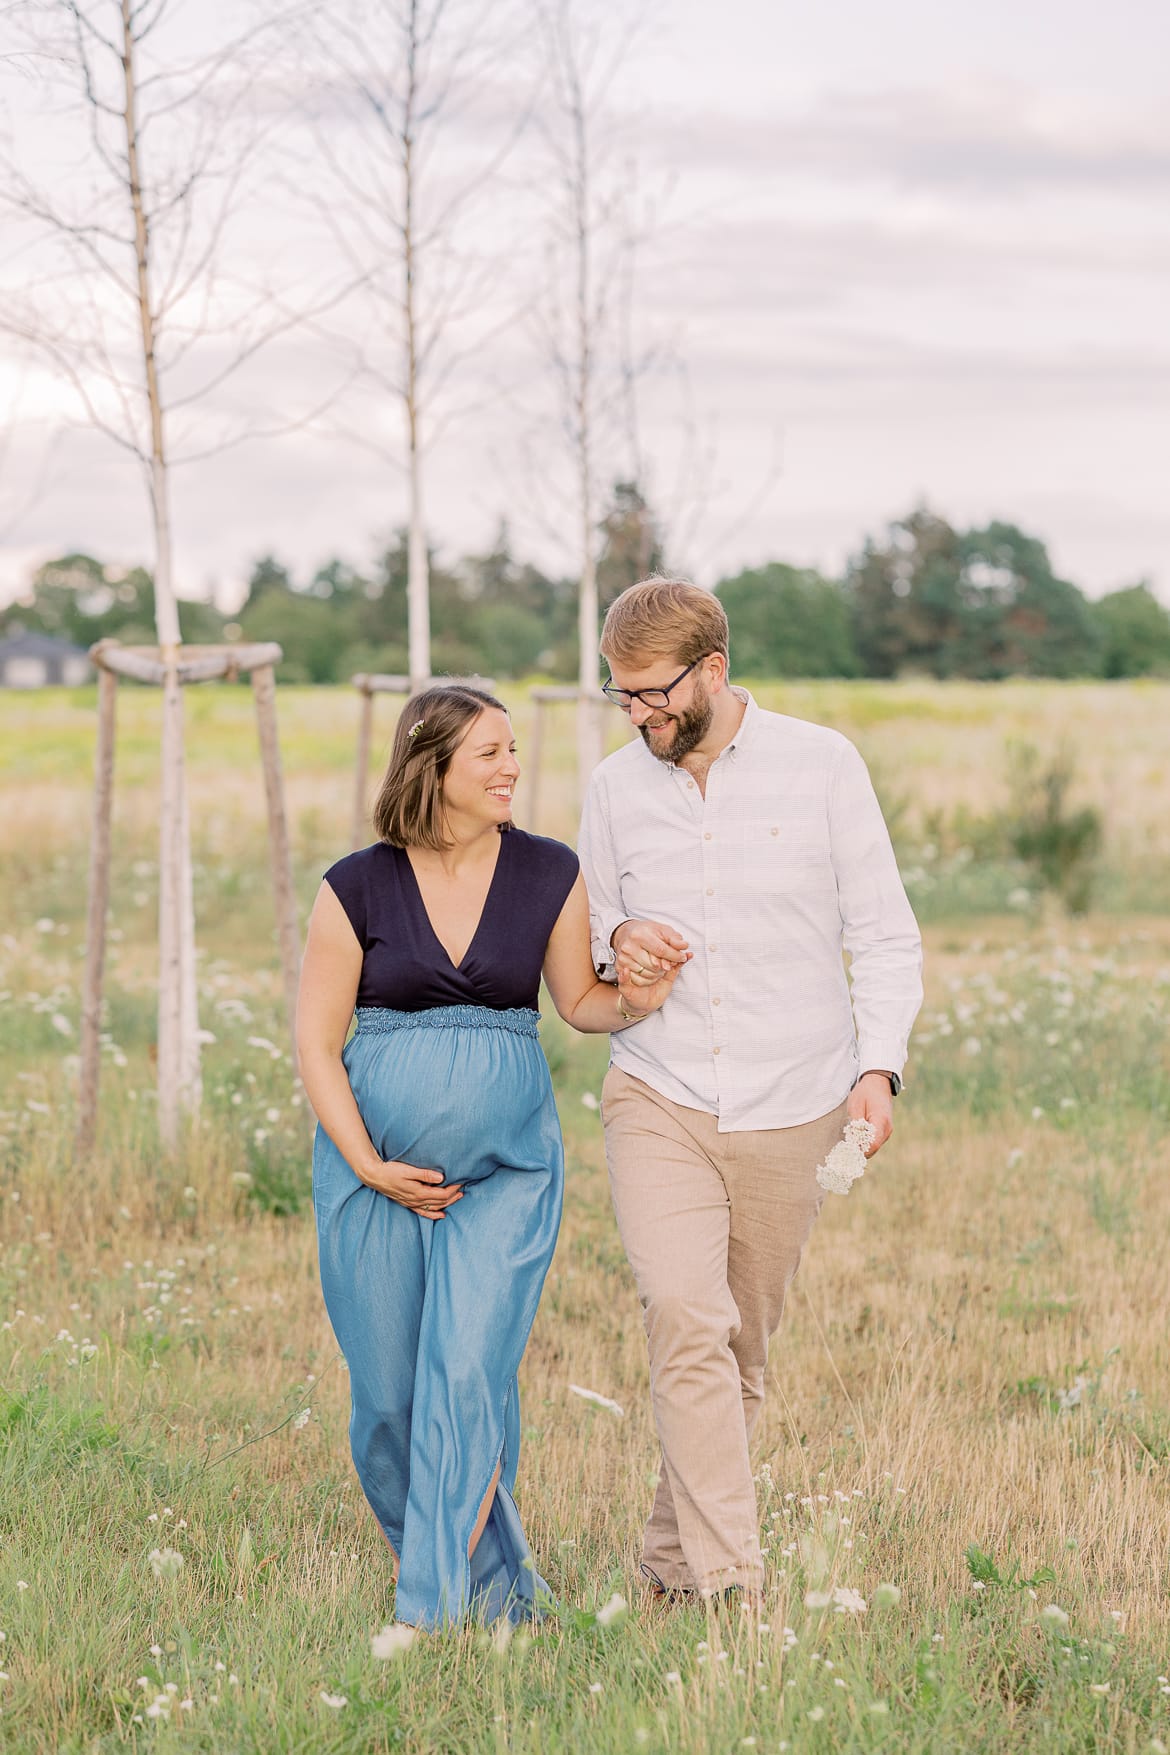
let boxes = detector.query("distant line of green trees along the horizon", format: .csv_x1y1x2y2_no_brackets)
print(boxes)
9,483,1170,683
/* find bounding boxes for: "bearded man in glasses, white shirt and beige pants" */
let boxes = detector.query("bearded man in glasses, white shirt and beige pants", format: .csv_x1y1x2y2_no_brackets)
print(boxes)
579,579,921,1602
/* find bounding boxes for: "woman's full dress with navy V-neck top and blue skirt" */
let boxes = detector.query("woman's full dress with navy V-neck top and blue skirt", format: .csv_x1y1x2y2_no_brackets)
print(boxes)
312,828,577,1627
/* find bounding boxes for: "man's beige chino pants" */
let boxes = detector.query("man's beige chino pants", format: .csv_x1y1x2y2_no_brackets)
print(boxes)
602,1067,845,1590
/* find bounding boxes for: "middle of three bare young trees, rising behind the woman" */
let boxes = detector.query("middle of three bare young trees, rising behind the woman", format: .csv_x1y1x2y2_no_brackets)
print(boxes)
291,0,526,688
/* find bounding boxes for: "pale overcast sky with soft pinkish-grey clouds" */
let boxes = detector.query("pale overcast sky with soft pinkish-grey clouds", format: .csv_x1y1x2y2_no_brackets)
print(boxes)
0,0,1170,605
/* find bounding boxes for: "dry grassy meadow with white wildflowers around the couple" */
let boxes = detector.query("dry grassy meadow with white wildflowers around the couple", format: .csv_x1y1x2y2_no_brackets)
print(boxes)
0,683,1170,1755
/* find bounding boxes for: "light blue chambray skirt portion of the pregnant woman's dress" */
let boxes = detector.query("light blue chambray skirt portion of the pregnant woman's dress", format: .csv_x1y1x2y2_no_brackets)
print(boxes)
312,1006,563,1627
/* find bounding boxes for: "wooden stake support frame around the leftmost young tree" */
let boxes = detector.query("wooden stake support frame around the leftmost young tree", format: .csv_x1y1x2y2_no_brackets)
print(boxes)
77,641,300,1162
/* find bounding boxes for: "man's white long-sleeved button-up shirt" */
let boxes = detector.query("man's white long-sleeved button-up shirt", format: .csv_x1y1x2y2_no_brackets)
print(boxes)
579,688,923,1134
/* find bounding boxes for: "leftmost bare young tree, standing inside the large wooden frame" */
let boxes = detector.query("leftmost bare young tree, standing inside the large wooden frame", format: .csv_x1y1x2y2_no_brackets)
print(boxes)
0,0,306,1148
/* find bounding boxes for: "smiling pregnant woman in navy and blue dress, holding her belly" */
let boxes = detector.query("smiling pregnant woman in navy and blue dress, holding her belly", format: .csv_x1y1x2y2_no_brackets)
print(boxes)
296,686,672,1629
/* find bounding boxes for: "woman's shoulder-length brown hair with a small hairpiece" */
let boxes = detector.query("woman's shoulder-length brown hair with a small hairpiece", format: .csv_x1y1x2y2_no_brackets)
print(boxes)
374,683,507,853
